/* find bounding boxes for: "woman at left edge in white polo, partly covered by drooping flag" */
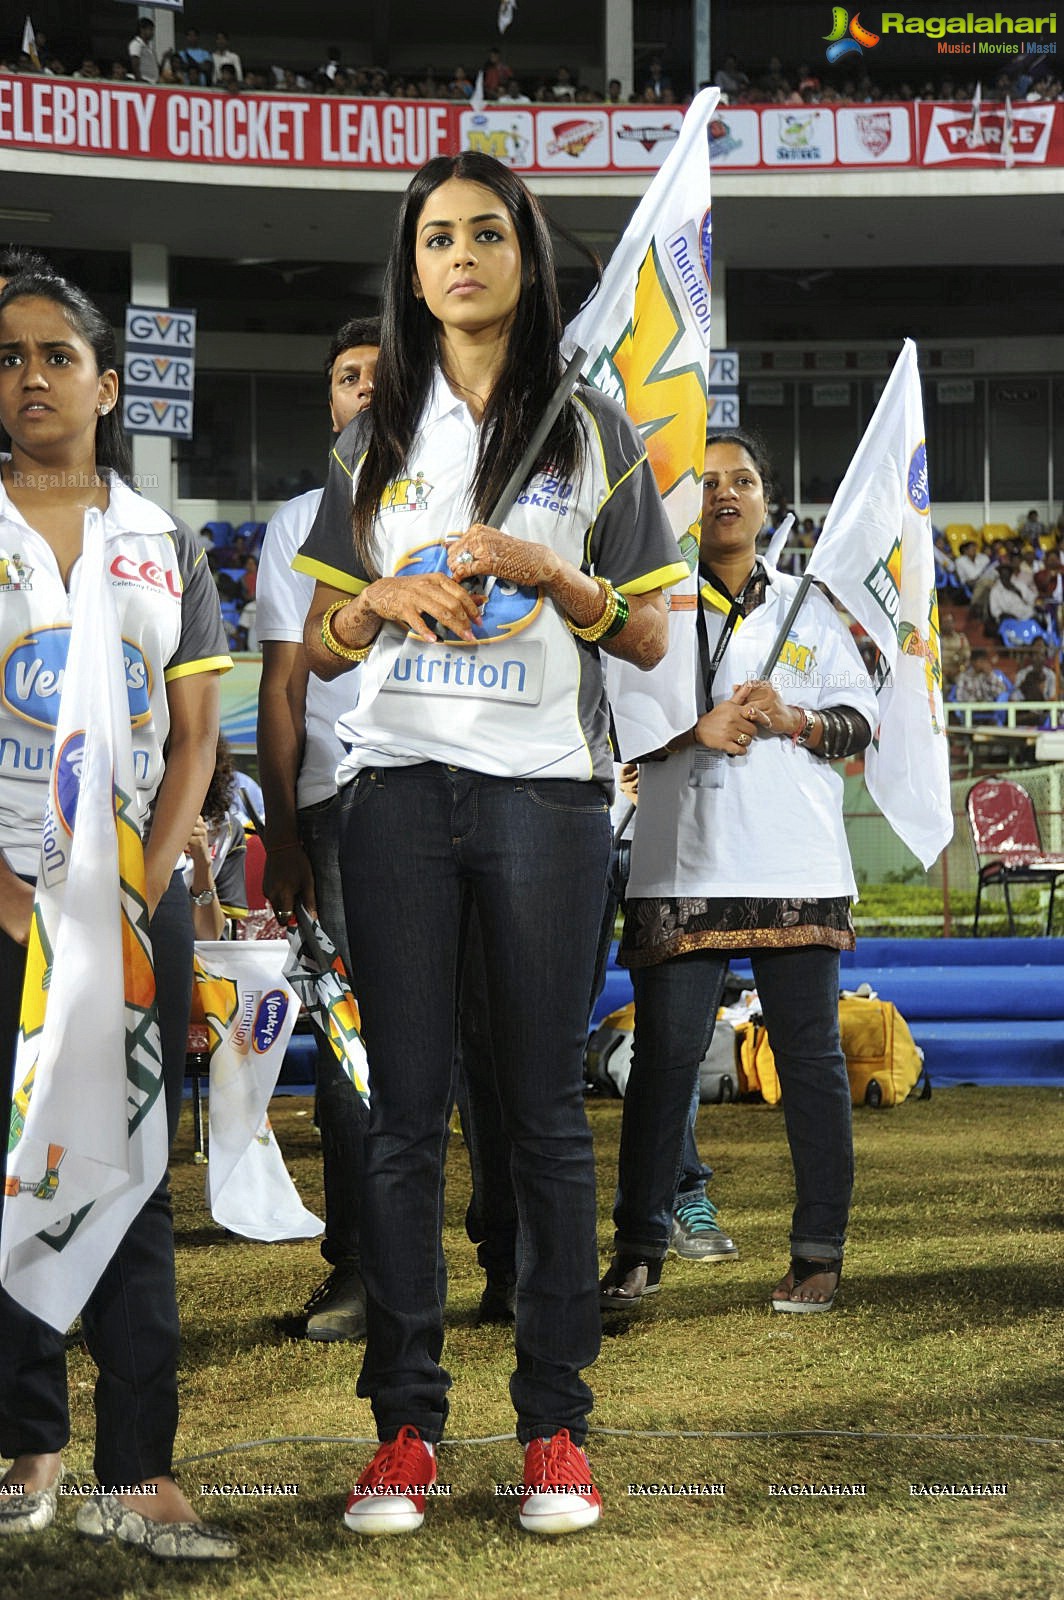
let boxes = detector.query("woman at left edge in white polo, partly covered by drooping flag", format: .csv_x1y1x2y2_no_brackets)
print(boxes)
0,275,237,1560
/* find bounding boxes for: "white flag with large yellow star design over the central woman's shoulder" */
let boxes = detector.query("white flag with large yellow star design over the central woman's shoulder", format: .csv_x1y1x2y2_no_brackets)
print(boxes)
563,88,720,760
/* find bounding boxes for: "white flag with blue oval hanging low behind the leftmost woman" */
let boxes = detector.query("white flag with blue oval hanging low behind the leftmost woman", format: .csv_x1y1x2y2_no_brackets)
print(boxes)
194,939,323,1240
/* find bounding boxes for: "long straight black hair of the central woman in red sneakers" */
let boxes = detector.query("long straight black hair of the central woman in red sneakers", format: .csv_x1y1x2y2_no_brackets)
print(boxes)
354,150,582,573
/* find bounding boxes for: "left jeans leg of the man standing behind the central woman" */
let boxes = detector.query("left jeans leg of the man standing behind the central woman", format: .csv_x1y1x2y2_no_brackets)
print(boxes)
299,795,368,1267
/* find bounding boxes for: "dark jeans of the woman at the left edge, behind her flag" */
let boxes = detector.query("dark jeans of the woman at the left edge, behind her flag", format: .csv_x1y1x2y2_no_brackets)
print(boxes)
0,872,192,1485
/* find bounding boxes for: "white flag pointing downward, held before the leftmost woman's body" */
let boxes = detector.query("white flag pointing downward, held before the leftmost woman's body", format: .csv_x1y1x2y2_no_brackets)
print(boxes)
0,510,168,1330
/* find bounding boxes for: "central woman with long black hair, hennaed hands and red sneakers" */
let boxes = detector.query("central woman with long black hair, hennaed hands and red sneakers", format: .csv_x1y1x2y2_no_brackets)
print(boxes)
296,154,686,1533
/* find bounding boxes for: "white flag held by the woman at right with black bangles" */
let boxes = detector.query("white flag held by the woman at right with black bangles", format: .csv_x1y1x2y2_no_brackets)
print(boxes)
806,339,954,867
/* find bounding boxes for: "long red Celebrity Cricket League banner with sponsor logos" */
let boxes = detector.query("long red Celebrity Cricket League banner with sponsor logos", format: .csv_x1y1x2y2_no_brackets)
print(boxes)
0,74,1064,176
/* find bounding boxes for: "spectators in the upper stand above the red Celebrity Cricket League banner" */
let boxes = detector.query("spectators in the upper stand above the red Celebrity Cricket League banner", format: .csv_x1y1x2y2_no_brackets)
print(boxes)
0,27,1064,106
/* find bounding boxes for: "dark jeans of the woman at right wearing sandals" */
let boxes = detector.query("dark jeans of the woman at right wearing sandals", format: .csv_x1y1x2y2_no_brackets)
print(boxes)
613,946,853,1261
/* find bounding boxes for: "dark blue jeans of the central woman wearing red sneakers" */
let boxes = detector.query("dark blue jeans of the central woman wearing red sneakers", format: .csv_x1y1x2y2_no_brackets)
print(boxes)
341,763,610,1442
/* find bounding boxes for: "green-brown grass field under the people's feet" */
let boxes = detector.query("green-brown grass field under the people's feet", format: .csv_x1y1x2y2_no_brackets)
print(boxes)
0,1088,1064,1600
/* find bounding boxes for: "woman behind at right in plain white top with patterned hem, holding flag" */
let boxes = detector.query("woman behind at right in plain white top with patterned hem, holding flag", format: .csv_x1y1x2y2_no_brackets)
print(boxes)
602,432,877,1312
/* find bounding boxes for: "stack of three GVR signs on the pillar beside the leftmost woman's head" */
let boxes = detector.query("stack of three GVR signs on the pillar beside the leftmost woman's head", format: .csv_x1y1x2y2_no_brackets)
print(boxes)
122,306,195,438
